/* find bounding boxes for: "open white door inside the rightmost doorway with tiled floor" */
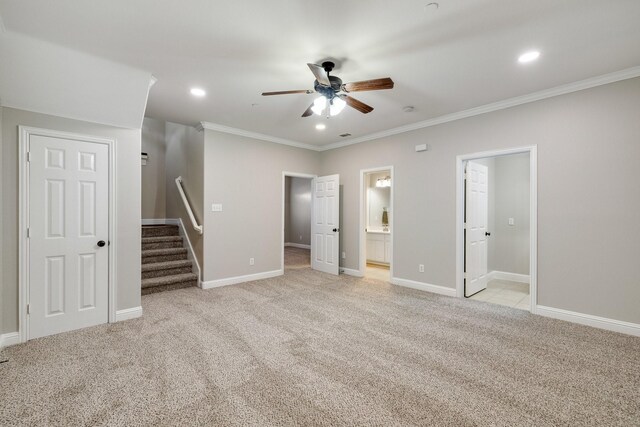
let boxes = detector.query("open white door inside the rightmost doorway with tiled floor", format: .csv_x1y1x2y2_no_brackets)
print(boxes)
464,162,489,297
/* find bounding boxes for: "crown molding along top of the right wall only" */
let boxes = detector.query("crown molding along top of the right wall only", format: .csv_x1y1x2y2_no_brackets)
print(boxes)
319,66,640,151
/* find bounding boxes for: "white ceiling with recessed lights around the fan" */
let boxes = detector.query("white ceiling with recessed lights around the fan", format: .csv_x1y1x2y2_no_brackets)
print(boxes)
0,0,640,146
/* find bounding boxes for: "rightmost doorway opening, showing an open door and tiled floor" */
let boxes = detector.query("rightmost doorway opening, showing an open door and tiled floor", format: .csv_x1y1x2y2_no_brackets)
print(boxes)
456,146,537,312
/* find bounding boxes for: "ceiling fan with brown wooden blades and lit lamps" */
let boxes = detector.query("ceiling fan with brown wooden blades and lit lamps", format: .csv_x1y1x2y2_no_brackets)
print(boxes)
262,61,393,117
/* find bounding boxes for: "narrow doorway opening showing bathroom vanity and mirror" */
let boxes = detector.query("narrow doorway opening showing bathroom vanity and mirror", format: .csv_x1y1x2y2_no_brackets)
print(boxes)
359,166,394,282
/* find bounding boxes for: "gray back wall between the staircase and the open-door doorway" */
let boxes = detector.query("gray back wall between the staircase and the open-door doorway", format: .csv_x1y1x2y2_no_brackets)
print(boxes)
204,129,320,280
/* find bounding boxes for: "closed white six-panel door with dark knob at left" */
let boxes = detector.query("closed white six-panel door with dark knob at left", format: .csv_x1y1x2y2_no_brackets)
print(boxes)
28,135,109,338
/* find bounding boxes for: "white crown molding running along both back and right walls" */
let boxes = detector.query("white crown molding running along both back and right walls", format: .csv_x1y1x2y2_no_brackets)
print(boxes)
197,66,640,155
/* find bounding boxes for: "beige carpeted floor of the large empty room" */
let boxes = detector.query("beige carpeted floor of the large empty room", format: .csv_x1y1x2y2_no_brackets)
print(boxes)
0,246,640,426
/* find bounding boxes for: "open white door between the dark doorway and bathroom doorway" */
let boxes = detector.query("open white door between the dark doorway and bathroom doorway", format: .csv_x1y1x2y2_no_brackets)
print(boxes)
311,175,340,275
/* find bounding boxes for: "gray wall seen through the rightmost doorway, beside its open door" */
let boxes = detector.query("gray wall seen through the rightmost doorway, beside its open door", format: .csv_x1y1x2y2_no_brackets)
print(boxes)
489,154,530,275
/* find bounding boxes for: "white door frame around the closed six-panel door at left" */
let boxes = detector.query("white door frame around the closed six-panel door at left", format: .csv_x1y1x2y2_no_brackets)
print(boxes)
18,126,117,342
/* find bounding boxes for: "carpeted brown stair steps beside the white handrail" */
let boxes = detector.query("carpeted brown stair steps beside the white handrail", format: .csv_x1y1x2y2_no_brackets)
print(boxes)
142,225,198,295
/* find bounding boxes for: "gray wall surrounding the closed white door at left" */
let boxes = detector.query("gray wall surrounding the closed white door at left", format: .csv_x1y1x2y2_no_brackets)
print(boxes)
0,108,141,333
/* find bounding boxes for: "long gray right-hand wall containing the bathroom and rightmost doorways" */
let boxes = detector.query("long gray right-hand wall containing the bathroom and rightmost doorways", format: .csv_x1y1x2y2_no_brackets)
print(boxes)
320,78,640,323
